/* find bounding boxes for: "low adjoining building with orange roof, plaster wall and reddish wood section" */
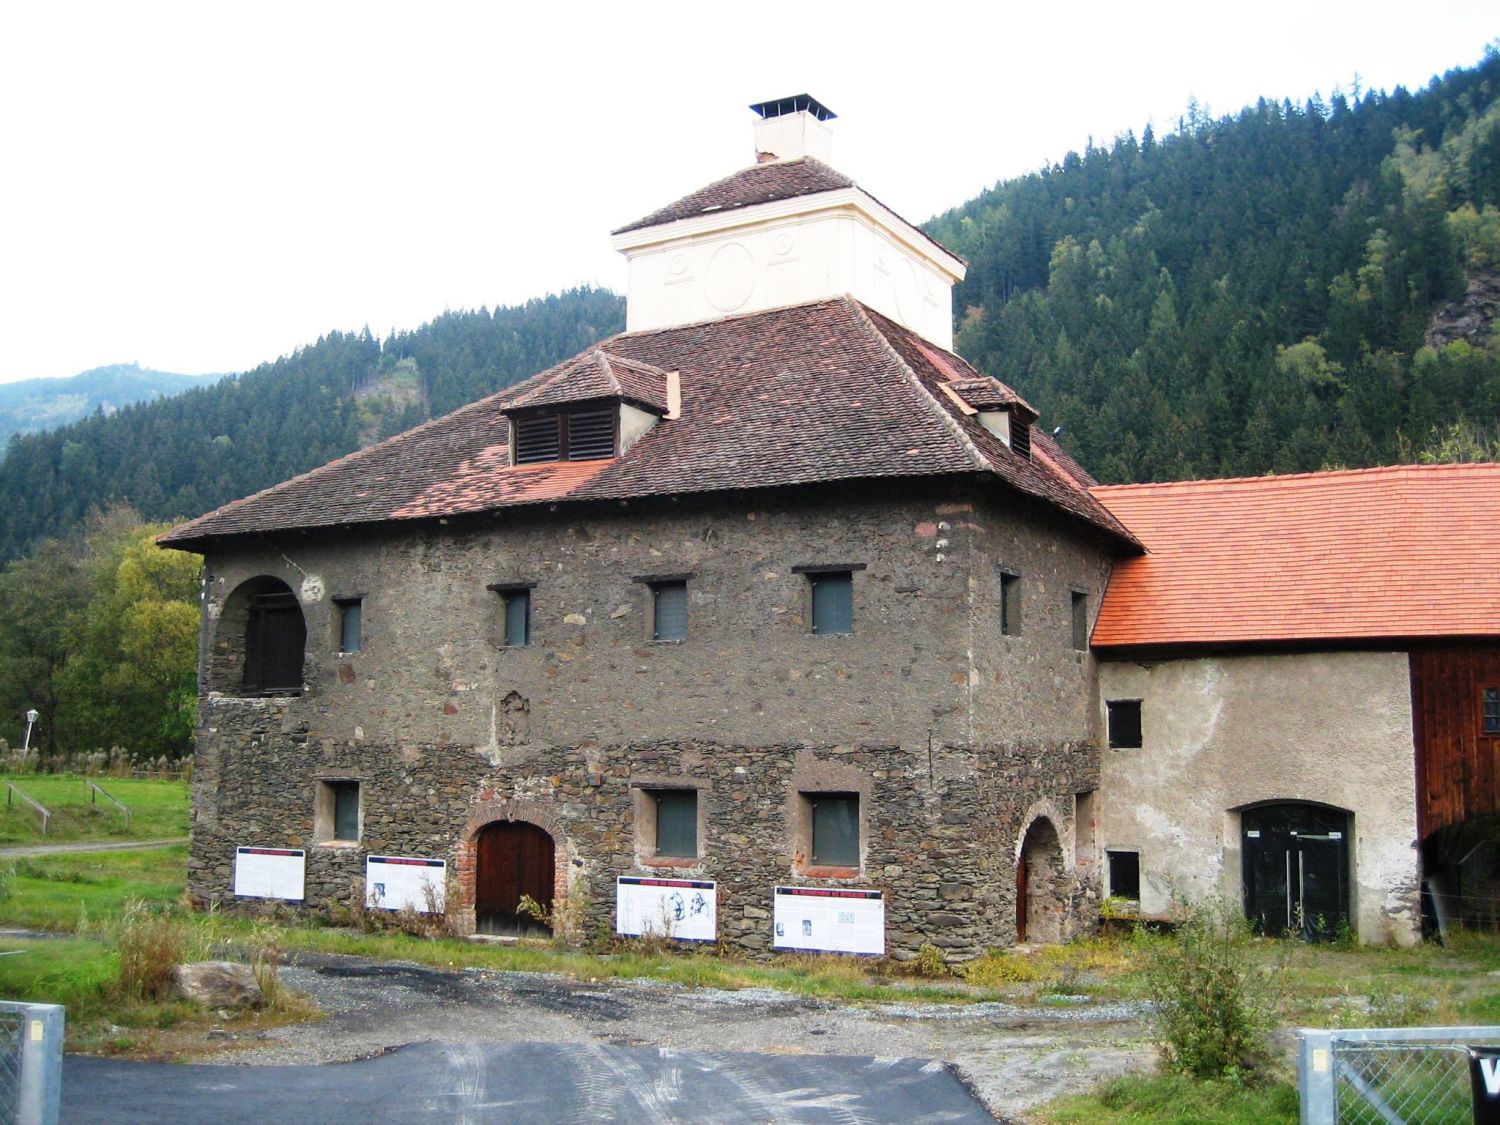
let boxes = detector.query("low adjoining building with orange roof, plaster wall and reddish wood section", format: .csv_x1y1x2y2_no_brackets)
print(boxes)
1092,465,1500,944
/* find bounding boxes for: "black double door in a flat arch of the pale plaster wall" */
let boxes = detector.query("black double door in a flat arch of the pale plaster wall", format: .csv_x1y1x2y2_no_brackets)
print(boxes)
1239,801,1349,941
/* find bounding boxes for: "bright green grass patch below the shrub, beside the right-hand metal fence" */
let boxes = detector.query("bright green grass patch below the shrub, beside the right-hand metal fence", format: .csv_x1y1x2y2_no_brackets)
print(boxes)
1035,1074,1298,1125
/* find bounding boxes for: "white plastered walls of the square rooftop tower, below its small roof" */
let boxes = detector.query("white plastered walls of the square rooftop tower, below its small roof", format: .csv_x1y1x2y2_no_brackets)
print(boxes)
621,201,956,350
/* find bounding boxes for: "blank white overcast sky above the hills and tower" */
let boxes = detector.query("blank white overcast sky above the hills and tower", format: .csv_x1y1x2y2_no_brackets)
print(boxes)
0,0,1500,381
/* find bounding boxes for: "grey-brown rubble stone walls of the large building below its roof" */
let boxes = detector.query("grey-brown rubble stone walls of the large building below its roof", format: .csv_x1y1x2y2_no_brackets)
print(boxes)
191,486,1107,959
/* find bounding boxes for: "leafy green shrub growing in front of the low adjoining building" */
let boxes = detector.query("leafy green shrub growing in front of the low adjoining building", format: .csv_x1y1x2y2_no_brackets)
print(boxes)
1139,902,1284,1079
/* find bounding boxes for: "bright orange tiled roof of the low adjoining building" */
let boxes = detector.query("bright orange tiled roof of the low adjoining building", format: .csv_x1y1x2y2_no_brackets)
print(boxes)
1094,465,1500,648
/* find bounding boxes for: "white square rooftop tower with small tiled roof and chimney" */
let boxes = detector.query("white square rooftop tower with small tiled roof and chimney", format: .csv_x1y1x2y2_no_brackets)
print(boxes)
612,95,966,350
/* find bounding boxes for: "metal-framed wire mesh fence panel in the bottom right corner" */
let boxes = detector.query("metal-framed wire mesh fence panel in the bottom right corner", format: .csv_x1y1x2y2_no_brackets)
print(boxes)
1298,1028,1500,1125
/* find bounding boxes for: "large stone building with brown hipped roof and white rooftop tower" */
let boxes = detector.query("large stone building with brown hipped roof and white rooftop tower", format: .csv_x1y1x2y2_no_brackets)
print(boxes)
155,98,1139,959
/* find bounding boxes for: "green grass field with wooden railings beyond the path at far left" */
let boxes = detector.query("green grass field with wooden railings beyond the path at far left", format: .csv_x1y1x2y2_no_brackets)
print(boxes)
0,774,188,848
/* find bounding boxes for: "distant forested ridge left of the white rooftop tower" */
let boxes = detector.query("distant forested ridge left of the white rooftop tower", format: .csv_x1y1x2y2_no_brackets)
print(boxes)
0,290,624,558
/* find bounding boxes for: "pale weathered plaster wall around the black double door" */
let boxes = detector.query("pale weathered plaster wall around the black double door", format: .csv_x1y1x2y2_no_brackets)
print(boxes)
1098,653,1421,944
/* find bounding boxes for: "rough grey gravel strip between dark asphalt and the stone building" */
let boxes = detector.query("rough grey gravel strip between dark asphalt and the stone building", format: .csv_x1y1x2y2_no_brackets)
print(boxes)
200,954,1154,1121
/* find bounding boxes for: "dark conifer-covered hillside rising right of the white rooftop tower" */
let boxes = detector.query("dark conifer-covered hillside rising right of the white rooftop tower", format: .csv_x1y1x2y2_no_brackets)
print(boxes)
927,51,1500,482
